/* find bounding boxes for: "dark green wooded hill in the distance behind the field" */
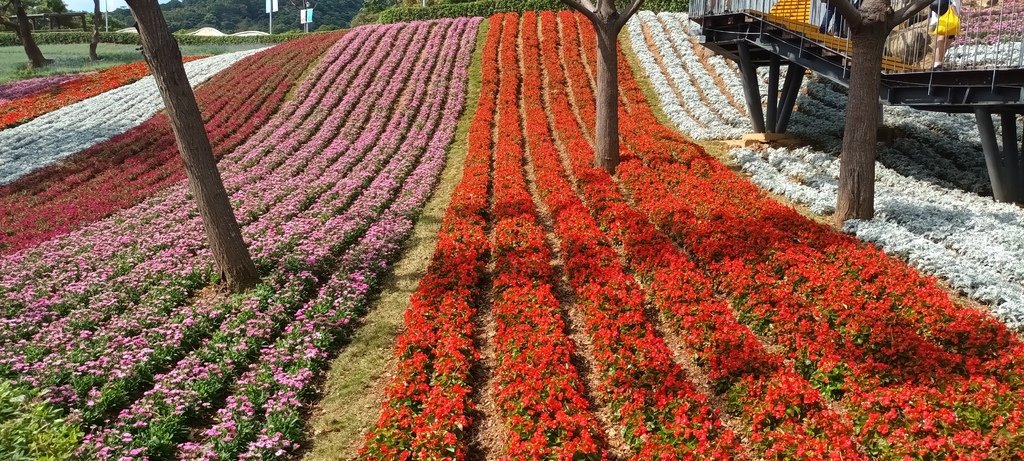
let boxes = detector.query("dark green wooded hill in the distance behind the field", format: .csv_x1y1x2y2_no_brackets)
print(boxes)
111,0,362,34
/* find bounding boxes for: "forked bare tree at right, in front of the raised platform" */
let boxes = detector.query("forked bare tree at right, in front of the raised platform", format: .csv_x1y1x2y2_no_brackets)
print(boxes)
828,0,932,226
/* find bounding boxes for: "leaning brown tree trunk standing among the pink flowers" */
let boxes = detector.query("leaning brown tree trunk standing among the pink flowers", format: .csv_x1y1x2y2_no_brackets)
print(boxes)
128,0,258,292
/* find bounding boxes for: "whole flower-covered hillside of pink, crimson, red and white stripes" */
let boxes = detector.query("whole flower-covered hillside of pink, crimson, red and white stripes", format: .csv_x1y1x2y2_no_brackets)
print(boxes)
0,5,1024,461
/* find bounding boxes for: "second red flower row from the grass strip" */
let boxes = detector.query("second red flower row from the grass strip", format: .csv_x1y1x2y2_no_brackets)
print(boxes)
492,13,603,460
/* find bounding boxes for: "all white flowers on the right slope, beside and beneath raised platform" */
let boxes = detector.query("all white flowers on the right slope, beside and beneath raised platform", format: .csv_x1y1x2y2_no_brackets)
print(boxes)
629,12,1024,329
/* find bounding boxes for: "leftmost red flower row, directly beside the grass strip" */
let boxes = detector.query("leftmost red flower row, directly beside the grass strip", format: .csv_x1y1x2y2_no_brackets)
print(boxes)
361,16,502,459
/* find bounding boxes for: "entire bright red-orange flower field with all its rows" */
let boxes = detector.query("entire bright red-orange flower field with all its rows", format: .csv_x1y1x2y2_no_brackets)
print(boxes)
362,12,1024,459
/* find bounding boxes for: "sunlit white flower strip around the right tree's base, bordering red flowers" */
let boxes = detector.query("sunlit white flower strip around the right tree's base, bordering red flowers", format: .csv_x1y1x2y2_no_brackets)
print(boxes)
730,148,1024,328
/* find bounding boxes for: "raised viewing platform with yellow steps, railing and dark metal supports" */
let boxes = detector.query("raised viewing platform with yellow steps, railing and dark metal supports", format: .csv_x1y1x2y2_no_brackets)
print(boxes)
689,0,1024,203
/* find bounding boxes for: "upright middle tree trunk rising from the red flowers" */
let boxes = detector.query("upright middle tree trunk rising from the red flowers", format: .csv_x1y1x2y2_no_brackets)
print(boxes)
594,24,618,174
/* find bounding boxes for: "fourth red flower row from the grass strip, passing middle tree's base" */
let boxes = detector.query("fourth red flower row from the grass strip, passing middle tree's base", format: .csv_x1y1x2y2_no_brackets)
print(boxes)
550,10,860,459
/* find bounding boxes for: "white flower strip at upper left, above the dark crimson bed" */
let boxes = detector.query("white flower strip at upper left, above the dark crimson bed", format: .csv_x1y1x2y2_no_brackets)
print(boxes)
0,50,259,184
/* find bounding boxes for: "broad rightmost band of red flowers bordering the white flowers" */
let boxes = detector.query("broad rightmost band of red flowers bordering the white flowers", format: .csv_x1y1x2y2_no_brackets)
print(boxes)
602,22,1024,458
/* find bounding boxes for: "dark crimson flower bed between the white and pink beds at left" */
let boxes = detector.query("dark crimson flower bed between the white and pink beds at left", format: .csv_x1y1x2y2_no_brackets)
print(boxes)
0,34,339,253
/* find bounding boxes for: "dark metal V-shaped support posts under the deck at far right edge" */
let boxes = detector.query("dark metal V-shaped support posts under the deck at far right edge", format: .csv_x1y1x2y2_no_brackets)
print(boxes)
974,108,1024,204
